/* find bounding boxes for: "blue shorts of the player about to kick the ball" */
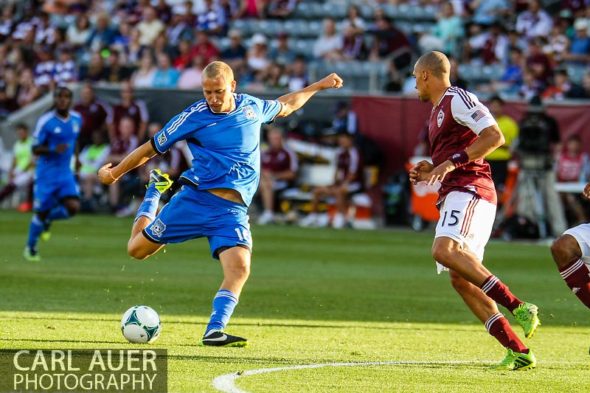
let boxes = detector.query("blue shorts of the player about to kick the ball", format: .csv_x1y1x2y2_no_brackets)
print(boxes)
143,185,252,259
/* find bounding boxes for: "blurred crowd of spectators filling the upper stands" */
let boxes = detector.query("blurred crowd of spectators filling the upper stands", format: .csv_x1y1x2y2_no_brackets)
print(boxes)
0,0,590,116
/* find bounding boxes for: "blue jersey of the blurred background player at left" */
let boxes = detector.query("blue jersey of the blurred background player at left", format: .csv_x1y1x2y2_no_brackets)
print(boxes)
33,111,82,179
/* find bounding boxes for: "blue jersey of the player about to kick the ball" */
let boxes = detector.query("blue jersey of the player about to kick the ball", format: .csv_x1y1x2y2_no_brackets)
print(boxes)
152,94,281,206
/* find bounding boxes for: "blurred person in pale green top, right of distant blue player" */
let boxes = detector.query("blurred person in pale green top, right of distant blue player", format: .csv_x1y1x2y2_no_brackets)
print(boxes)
79,129,110,211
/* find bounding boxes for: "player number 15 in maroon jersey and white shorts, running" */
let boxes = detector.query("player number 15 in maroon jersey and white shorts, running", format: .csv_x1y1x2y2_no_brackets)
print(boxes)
410,51,540,370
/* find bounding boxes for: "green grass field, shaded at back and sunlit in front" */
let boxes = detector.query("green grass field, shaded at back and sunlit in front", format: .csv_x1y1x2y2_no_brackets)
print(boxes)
0,211,590,393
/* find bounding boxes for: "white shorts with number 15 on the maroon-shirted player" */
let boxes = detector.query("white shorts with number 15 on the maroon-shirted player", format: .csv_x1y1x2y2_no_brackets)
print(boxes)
434,191,496,273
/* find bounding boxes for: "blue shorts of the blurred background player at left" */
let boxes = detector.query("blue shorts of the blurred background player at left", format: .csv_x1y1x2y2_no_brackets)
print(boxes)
33,173,80,213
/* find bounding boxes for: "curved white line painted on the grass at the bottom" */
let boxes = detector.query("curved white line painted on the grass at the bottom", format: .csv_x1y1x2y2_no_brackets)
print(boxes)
213,360,493,393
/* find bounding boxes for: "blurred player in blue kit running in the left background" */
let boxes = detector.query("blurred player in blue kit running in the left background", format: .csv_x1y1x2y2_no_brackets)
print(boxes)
23,87,82,261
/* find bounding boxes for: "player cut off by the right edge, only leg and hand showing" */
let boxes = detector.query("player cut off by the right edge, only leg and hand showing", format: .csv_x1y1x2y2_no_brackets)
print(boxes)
551,183,590,314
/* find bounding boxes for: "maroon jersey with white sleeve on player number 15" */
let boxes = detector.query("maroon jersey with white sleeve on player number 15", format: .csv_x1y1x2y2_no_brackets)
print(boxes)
428,87,497,204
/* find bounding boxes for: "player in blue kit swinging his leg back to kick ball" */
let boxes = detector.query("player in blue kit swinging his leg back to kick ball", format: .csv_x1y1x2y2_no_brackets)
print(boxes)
98,61,343,347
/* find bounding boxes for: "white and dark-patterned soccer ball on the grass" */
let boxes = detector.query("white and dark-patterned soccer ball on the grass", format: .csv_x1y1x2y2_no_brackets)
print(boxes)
121,306,162,343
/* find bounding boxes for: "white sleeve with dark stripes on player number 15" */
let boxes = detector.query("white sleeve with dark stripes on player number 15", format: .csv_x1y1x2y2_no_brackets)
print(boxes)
451,90,498,135
